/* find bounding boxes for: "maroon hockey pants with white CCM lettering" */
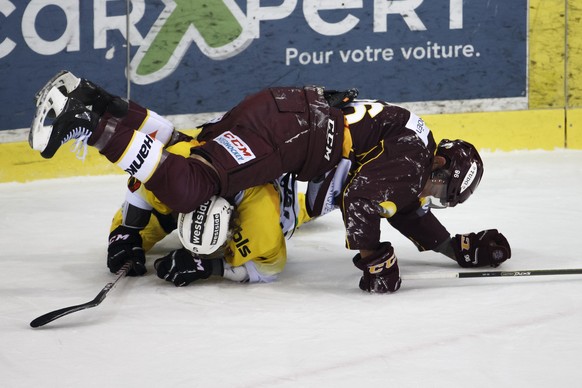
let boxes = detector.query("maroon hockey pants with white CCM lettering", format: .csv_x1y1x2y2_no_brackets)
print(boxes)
193,87,344,196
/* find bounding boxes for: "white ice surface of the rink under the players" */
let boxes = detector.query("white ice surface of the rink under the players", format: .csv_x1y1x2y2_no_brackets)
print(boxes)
0,150,582,388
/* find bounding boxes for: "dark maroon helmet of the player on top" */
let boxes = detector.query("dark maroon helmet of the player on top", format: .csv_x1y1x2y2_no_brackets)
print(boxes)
431,139,483,207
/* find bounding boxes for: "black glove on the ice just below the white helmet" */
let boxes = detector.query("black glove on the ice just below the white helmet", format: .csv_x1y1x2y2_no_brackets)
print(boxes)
154,248,212,287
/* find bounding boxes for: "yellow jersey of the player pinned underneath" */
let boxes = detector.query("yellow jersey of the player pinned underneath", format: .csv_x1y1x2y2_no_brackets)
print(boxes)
111,136,309,282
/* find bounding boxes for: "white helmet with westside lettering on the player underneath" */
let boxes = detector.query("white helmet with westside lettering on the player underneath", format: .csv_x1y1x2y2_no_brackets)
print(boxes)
178,196,232,255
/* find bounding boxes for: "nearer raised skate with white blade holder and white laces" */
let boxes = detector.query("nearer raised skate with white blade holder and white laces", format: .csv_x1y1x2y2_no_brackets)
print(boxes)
28,84,100,159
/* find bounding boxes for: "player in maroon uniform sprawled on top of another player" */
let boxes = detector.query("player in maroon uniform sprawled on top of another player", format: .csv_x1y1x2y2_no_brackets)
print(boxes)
29,73,511,293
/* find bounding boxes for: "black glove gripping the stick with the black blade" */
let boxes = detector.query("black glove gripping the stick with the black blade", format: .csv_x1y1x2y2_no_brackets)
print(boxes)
107,225,146,276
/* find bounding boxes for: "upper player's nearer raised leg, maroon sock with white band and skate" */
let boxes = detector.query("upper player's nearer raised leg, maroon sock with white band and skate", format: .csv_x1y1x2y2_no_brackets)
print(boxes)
29,75,221,212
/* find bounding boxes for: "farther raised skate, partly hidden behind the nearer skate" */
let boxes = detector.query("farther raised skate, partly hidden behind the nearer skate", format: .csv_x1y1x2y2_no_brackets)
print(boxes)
35,70,128,117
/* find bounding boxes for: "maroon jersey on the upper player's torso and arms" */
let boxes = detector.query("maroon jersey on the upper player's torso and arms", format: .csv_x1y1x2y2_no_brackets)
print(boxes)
338,100,440,250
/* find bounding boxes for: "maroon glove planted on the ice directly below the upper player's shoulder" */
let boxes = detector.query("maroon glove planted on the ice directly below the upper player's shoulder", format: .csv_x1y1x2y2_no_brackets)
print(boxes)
353,242,402,294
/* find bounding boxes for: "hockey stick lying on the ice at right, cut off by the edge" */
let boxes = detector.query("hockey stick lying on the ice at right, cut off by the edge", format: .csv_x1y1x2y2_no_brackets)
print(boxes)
402,268,582,280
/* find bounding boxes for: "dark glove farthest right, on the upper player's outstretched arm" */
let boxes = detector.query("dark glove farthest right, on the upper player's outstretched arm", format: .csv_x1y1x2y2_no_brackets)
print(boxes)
451,229,511,268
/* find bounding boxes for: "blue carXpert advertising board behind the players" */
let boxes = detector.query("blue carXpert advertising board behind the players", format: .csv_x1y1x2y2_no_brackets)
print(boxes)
0,0,528,129
